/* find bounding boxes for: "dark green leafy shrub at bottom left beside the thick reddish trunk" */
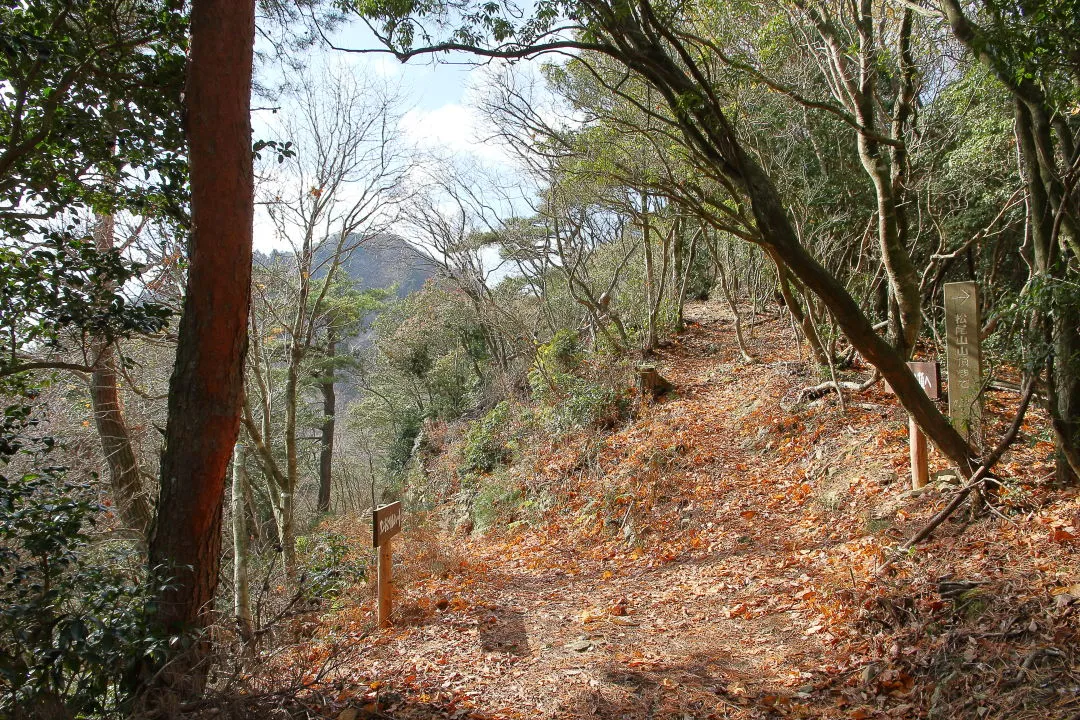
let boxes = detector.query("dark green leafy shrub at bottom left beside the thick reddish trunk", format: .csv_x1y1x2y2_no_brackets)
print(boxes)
0,407,166,718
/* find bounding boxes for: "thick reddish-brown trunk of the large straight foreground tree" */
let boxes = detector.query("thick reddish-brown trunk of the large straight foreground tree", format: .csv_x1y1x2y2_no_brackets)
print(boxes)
149,0,255,697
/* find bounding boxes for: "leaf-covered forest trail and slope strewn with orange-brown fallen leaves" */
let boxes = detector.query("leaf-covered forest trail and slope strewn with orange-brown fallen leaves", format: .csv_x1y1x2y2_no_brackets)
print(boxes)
313,303,1080,720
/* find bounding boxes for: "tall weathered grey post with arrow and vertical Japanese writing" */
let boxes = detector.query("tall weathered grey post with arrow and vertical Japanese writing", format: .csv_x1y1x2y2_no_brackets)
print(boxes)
945,283,983,441
